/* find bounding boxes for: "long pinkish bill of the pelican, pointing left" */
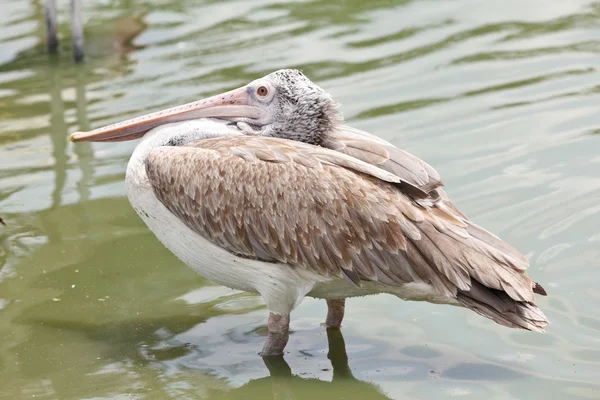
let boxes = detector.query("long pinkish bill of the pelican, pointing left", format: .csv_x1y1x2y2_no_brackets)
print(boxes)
69,87,261,142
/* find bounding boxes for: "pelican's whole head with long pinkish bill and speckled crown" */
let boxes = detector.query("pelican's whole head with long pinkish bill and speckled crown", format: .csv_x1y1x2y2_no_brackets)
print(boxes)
70,69,342,145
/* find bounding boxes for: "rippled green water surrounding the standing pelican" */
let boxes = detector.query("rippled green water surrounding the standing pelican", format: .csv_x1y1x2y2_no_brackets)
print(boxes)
0,0,600,400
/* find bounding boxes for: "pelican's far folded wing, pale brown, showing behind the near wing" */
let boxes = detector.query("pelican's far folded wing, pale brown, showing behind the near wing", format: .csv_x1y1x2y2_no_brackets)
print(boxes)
324,125,546,301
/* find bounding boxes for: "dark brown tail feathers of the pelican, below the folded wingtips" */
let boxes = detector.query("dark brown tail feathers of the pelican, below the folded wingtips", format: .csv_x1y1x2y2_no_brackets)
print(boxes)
457,280,548,332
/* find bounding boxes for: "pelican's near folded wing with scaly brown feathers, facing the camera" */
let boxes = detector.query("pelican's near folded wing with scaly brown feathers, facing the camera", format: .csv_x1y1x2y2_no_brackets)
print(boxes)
146,136,546,330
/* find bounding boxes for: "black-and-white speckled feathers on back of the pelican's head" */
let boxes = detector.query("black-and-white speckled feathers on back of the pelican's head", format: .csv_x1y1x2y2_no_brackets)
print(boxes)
263,69,343,145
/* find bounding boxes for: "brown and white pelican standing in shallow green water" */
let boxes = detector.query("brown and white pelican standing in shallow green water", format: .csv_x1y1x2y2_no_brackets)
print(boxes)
70,70,548,356
